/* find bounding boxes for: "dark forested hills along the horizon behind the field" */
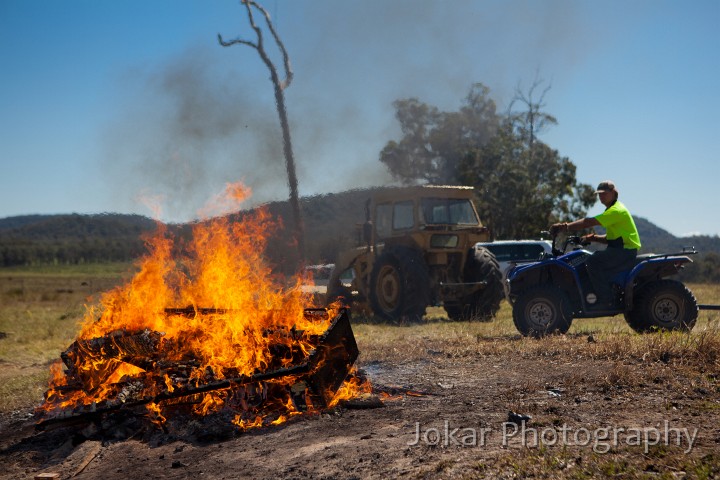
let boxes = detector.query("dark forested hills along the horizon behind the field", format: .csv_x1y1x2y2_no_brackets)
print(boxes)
0,187,720,274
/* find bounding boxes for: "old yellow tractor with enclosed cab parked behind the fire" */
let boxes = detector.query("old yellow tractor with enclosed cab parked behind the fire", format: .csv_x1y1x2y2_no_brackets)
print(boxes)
327,185,504,321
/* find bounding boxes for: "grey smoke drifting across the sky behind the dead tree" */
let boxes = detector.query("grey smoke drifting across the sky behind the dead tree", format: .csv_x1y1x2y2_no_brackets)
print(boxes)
101,0,593,221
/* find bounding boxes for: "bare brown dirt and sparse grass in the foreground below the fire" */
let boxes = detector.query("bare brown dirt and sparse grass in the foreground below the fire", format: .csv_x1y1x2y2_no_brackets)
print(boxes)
0,328,720,480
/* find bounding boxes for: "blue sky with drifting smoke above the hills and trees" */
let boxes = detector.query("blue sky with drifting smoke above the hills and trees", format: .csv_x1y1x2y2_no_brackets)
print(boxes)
0,0,720,235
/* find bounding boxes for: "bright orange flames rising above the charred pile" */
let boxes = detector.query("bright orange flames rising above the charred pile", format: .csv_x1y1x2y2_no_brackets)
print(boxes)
41,184,360,429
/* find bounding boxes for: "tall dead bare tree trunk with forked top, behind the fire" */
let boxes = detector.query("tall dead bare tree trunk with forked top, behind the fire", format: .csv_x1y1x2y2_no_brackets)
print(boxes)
218,0,305,263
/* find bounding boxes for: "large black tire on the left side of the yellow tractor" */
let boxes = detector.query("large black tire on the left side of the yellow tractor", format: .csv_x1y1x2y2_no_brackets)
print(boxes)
369,248,430,323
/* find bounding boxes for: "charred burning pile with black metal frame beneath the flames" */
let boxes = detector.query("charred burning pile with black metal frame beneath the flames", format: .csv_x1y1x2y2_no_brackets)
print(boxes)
36,307,359,430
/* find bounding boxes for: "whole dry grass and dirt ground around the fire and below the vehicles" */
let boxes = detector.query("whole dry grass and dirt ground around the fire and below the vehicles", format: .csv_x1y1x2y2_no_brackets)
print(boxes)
0,266,720,479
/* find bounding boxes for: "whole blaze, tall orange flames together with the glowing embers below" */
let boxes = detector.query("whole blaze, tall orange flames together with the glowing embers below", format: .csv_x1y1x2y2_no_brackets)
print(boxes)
39,184,358,429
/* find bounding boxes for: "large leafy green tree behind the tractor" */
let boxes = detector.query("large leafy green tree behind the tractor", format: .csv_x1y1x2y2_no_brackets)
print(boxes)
380,82,596,239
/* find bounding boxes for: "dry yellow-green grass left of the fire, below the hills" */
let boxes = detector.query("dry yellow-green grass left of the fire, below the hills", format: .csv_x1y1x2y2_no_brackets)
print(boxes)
0,265,134,413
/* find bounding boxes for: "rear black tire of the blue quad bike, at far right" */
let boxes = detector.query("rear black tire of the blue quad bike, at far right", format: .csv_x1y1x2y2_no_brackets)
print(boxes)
625,280,698,333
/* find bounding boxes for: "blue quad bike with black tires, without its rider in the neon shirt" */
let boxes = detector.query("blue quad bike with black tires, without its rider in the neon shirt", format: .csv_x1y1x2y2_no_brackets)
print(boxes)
507,232,718,337
